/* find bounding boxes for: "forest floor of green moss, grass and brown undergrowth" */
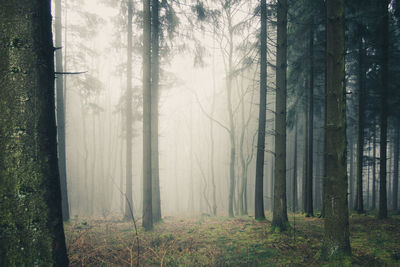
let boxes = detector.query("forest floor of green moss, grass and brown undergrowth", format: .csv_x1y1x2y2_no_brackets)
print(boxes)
65,214,400,266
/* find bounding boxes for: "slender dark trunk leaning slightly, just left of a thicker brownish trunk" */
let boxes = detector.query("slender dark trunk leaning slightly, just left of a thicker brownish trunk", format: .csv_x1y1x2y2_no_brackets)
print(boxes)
254,0,267,219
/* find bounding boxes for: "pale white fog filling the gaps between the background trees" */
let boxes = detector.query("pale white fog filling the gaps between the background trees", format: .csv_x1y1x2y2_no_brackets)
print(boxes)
57,0,301,218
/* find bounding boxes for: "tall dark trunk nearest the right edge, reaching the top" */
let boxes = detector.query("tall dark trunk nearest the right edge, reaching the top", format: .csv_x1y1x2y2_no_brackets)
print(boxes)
378,0,389,219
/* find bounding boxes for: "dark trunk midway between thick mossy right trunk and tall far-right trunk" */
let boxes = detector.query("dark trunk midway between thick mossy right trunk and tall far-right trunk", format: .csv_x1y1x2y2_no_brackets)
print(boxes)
355,31,365,214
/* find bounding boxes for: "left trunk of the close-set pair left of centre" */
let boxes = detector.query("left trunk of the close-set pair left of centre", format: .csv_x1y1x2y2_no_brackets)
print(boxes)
142,0,153,231
